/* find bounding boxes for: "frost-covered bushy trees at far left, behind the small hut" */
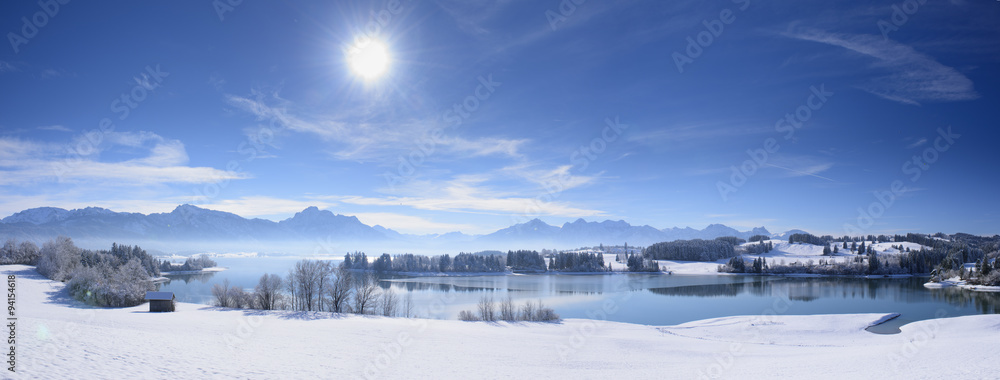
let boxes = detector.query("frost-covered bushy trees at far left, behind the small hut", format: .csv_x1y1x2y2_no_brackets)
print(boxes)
0,236,160,307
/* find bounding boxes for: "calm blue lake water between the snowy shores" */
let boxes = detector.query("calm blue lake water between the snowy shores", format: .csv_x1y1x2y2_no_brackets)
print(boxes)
160,257,1000,332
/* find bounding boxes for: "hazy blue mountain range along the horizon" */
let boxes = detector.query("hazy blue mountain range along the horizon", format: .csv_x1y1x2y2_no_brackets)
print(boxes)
0,204,799,249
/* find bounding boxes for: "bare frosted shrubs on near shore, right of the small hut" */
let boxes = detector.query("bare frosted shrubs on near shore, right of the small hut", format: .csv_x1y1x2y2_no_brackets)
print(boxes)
212,255,413,317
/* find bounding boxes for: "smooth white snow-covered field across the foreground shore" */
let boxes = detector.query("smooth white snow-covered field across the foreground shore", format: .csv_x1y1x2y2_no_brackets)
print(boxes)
7,265,1000,379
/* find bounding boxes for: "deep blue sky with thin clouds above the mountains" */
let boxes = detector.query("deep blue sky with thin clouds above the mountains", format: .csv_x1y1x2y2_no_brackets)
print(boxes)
0,0,1000,235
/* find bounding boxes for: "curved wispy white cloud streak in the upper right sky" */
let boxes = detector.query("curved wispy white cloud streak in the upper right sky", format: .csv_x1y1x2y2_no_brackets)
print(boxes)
784,29,979,105
